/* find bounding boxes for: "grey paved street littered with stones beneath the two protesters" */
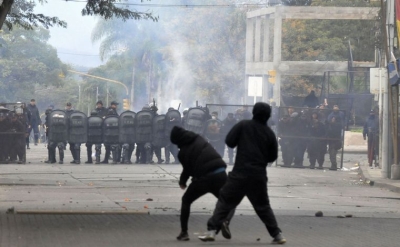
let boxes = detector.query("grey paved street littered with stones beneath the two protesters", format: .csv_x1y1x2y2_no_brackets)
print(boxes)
0,144,400,246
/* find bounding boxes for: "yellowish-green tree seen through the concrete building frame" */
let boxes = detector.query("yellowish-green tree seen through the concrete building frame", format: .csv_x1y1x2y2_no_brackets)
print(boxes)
282,0,380,98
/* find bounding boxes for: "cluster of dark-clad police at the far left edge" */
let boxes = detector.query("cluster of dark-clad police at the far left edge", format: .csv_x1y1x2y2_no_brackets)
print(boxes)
0,103,28,164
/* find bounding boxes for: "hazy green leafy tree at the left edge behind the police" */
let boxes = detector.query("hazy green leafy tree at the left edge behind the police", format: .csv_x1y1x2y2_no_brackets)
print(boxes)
0,28,67,102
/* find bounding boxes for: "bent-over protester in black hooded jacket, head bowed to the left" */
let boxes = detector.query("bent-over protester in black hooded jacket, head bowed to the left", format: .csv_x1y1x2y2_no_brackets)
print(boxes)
170,126,234,241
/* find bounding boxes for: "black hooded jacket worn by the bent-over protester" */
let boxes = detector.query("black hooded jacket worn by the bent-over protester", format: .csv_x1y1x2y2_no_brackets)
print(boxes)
171,126,226,186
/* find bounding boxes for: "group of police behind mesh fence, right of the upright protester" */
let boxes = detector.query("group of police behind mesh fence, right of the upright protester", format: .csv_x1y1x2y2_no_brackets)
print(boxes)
278,106,345,170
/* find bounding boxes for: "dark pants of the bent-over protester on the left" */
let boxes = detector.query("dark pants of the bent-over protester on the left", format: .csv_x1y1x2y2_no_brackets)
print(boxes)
181,171,235,232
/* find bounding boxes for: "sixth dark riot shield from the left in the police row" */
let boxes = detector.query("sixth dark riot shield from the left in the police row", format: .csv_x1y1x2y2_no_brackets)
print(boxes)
136,111,153,143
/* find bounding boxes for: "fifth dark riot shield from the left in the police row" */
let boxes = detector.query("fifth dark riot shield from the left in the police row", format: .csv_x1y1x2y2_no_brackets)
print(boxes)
119,111,136,144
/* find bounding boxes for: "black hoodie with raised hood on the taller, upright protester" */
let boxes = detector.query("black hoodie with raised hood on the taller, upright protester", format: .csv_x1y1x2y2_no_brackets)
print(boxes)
225,102,278,176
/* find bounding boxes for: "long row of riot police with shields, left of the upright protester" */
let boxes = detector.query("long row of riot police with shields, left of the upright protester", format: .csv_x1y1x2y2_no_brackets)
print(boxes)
45,101,248,164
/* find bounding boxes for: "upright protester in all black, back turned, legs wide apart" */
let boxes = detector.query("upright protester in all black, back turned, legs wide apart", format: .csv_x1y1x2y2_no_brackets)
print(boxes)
199,102,286,244
